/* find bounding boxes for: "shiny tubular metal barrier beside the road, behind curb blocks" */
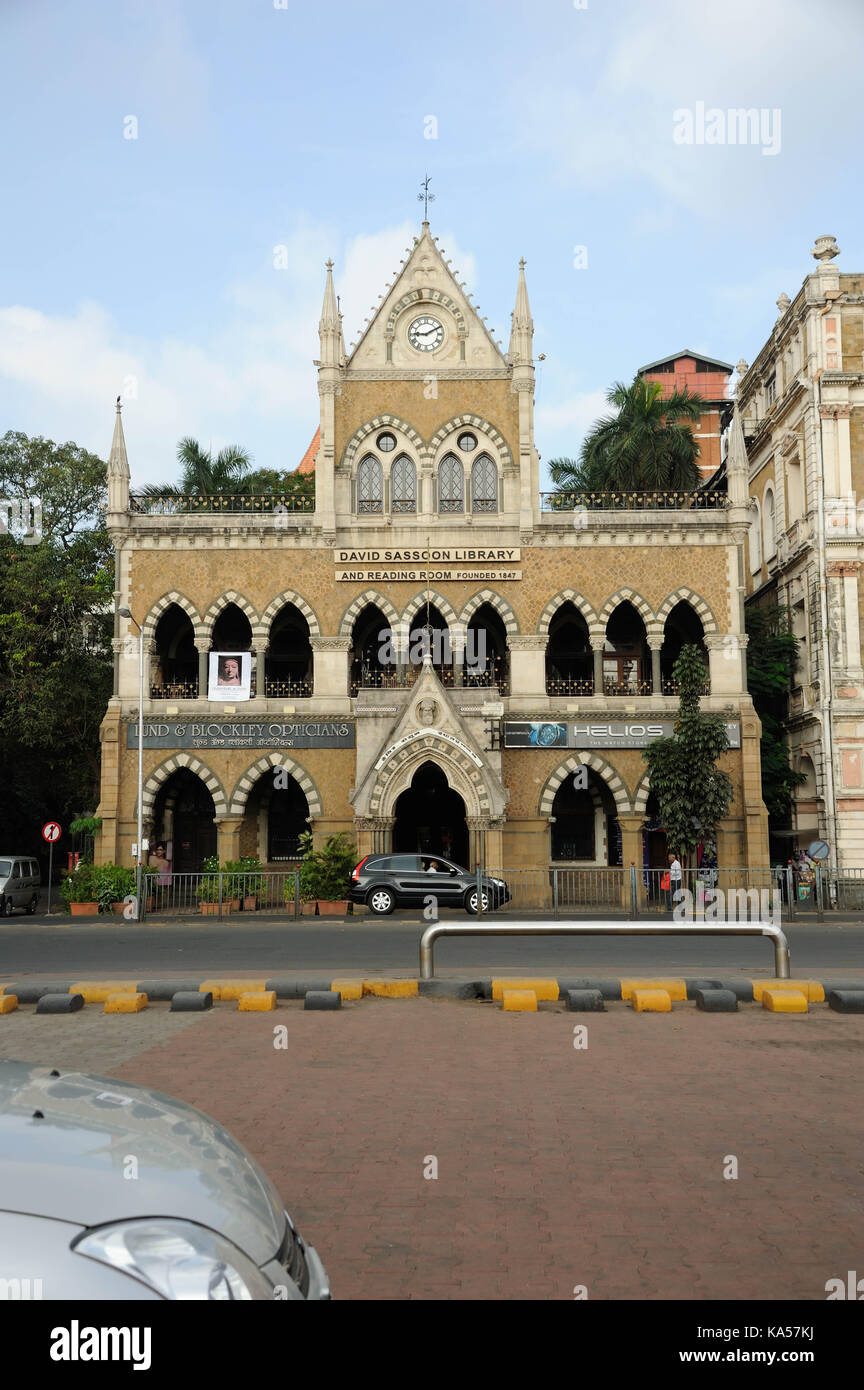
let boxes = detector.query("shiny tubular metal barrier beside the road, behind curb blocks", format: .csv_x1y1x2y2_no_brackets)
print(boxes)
419,922,790,980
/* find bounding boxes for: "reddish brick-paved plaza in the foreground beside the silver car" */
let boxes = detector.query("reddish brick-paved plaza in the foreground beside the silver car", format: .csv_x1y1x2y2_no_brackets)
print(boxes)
0,999,864,1300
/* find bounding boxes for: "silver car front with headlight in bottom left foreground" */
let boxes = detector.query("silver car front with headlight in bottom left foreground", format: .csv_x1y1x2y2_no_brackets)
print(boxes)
0,1061,331,1301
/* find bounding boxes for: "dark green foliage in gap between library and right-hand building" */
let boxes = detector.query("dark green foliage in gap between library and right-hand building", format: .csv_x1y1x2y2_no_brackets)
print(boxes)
745,605,806,821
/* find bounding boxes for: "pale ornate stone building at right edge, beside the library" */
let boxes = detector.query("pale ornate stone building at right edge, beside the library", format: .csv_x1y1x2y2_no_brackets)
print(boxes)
731,236,864,869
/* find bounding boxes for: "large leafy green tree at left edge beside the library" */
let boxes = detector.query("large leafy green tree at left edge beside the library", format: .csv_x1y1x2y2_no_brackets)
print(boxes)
0,431,114,851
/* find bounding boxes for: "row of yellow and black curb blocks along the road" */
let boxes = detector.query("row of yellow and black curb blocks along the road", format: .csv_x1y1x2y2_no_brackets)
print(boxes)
0,974,864,1017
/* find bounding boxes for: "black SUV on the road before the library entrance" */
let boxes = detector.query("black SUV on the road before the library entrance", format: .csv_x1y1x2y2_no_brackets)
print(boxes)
349,855,510,917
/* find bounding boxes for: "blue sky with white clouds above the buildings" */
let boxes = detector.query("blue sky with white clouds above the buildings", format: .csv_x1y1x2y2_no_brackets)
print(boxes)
0,0,864,484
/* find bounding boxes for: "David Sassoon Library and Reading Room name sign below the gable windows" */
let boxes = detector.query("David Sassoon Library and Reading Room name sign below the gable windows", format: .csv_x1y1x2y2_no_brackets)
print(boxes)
333,545,522,584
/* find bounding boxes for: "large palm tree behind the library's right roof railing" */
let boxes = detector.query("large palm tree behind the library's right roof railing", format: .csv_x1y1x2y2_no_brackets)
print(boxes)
549,377,703,492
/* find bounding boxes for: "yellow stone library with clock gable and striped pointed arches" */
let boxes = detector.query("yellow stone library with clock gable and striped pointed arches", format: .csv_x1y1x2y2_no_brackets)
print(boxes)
99,224,767,873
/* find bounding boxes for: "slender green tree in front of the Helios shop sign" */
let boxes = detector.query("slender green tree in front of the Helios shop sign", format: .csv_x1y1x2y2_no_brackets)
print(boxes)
645,644,732,867
